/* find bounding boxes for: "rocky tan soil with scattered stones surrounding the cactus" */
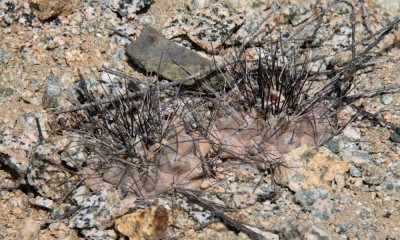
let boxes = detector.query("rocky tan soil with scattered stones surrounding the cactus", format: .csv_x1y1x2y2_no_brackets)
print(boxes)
0,0,400,240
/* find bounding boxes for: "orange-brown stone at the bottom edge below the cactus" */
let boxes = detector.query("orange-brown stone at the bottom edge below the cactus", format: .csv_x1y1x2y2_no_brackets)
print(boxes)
115,206,169,240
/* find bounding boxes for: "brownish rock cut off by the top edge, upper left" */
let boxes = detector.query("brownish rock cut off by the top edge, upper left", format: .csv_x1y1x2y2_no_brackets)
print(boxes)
30,0,82,21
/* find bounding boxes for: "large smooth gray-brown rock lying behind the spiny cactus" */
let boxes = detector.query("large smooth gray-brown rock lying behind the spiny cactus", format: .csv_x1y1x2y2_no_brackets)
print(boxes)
126,27,227,85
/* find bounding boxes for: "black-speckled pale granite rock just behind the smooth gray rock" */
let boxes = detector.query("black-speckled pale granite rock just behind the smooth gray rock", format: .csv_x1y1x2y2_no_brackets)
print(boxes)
162,4,243,53
